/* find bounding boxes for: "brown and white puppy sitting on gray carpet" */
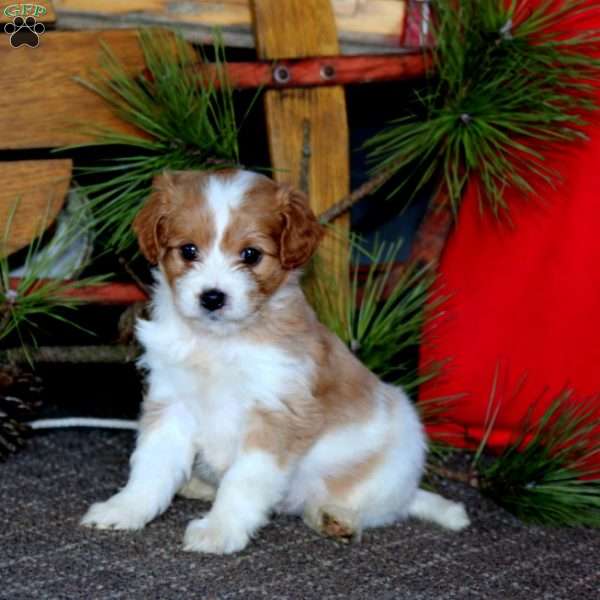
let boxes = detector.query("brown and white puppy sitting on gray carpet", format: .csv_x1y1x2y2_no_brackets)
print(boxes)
82,170,469,554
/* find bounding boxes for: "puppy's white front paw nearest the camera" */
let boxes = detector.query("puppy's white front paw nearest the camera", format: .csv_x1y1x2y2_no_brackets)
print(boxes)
183,517,250,554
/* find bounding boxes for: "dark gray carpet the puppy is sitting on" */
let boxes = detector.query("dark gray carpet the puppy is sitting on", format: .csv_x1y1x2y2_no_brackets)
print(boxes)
0,431,600,600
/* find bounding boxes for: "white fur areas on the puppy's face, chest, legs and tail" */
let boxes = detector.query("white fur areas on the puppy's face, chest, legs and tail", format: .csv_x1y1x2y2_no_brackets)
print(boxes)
82,174,468,553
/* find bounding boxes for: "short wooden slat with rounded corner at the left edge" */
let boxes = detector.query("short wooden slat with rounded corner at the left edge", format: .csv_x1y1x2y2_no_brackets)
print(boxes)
0,159,73,257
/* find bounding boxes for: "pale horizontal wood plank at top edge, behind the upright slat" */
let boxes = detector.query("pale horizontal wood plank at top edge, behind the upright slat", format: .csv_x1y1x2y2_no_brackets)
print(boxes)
54,0,406,53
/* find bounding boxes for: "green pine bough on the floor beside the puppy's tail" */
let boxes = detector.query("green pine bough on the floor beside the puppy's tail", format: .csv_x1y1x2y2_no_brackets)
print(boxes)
428,369,600,527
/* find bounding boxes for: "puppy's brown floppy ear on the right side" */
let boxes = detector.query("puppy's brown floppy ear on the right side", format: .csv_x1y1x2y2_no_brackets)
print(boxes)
279,186,324,269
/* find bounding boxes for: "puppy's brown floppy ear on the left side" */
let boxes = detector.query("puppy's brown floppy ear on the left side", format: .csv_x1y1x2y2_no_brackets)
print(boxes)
133,172,173,265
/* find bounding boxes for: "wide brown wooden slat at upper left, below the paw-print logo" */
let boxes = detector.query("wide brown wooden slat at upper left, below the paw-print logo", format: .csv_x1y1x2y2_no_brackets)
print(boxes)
0,31,144,149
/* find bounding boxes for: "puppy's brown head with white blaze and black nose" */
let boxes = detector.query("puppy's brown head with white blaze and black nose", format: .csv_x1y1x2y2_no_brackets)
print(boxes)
133,170,322,331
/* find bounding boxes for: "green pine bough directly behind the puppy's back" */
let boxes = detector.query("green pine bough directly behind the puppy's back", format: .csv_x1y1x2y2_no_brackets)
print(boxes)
304,234,440,393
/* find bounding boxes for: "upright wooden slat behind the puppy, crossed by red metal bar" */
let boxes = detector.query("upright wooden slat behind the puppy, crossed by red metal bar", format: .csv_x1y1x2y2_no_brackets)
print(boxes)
254,0,350,285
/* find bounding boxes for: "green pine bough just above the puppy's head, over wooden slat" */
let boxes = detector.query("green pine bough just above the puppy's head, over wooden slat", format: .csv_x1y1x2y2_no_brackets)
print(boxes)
67,30,246,252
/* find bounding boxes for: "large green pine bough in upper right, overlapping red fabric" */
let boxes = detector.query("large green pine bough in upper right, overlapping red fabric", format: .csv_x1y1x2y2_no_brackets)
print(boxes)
366,0,600,215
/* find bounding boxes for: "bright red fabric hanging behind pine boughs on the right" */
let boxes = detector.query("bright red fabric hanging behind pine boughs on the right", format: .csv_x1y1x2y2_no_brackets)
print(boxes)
421,0,600,446
